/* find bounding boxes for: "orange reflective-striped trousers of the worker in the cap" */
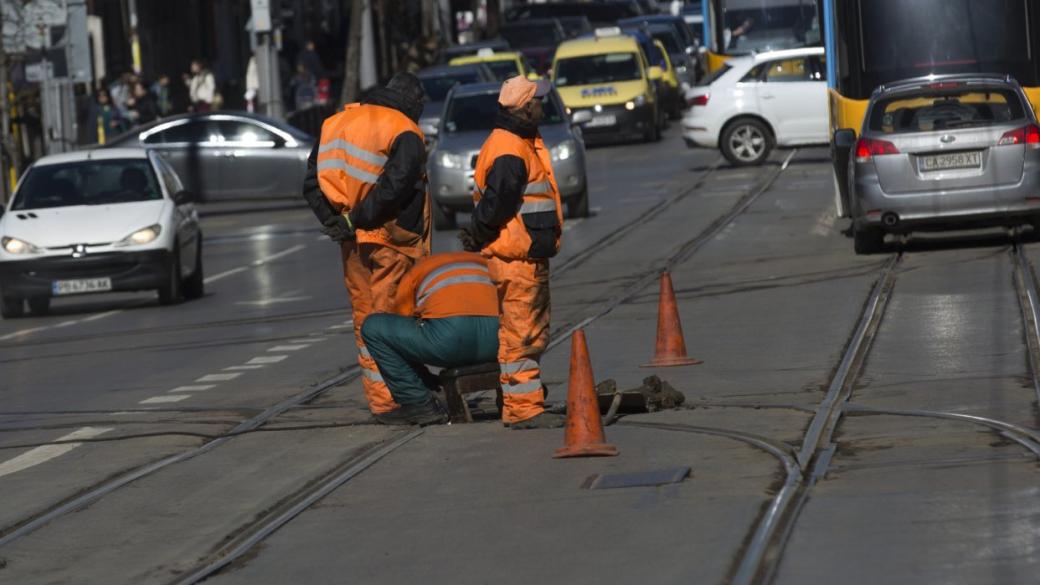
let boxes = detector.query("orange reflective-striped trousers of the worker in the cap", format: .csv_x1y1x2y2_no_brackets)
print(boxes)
488,257,549,424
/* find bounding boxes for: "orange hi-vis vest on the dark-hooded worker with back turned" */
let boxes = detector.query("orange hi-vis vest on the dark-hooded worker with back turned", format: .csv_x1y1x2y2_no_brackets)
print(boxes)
317,103,430,258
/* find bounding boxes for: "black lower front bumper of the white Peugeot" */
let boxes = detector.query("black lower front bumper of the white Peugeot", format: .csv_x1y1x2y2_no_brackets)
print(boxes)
0,250,171,298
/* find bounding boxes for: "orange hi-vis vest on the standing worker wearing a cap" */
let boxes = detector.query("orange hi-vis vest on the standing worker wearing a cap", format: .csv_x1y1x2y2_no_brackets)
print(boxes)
473,128,564,260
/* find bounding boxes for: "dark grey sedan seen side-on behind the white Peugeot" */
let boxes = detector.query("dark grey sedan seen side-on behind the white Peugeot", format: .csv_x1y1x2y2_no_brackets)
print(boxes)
106,111,314,201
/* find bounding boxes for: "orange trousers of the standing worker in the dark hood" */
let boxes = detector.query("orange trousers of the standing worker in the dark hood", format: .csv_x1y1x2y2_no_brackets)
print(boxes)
340,241,415,414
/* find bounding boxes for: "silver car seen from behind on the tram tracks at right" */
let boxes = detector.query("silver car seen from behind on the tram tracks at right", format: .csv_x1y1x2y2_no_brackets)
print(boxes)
835,75,1040,254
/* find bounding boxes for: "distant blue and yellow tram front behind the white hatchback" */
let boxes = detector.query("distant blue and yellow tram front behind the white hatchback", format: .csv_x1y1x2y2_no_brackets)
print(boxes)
701,0,823,74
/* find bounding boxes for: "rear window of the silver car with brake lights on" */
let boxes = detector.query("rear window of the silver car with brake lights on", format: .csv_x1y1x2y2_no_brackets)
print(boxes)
868,84,1025,134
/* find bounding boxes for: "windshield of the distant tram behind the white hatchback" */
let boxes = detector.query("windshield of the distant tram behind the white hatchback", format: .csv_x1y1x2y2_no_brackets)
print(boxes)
722,0,821,55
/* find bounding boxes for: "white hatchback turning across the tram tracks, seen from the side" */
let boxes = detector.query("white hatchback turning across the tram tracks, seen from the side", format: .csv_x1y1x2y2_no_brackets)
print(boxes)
682,47,828,166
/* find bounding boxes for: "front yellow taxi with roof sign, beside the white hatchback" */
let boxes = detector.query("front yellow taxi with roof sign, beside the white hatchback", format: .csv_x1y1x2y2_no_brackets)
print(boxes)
552,28,664,143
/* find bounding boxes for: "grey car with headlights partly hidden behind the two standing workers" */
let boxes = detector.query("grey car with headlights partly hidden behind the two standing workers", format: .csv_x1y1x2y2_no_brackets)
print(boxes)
427,83,589,229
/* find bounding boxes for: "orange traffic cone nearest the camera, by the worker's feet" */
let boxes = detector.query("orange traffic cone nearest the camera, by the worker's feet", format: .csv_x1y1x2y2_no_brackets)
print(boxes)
553,329,618,458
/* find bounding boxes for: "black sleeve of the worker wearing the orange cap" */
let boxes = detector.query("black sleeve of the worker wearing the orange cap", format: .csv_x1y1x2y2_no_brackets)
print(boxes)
471,154,527,244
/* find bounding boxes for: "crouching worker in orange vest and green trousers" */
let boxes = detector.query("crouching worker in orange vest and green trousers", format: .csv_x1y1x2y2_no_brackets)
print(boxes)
361,252,498,425
